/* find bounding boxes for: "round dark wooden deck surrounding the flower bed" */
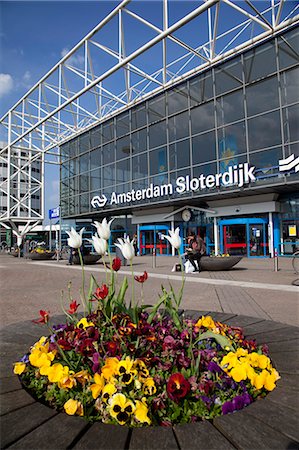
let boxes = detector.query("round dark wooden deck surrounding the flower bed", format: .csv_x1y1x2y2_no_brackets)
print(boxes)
0,312,299,450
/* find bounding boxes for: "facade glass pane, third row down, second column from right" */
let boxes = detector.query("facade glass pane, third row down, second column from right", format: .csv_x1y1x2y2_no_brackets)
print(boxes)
248,111,281,150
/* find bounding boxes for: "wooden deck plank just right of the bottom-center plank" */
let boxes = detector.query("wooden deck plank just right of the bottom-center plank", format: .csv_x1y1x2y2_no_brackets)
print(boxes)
174,421,235,450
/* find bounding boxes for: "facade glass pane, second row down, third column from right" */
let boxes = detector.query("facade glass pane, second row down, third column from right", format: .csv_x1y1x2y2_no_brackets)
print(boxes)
216,89,244,126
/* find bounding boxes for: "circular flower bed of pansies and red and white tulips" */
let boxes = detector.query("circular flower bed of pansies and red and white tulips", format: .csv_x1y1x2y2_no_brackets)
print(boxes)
14,219,279,427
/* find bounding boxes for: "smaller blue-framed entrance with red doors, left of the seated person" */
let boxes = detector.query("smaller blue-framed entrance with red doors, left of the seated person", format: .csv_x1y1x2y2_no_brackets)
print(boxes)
139,225,171,255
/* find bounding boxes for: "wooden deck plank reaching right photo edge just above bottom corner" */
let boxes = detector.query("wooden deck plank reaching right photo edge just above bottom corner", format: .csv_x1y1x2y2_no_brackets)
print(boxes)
244,397,299,442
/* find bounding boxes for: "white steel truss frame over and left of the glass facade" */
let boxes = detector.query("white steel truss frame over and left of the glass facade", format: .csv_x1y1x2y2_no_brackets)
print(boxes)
0,0,299,230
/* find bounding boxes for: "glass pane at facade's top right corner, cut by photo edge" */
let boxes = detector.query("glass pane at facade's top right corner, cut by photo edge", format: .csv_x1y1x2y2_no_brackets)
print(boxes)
278,28,299,69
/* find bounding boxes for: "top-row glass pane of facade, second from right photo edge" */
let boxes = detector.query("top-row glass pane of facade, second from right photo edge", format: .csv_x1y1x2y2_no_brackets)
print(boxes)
244,41,277,83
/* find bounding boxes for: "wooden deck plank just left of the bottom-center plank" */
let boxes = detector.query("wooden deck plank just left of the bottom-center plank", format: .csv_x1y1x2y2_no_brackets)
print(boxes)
72,423,129,450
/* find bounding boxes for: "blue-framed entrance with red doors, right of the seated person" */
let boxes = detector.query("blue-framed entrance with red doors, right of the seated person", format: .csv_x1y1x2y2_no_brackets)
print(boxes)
219,218,269,257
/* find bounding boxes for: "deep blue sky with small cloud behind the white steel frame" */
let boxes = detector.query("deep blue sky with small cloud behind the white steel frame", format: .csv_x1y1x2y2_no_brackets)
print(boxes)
0,0,296,221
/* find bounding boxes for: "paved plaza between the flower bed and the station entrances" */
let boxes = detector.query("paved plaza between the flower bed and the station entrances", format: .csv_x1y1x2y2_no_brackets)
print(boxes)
0,255,299,327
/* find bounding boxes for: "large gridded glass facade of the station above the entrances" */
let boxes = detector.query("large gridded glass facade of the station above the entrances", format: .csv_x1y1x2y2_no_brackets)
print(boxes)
61,28,299,217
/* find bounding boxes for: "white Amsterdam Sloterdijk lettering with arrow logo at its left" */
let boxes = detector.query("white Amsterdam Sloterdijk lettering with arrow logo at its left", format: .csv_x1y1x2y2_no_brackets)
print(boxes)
90,163,256,209
